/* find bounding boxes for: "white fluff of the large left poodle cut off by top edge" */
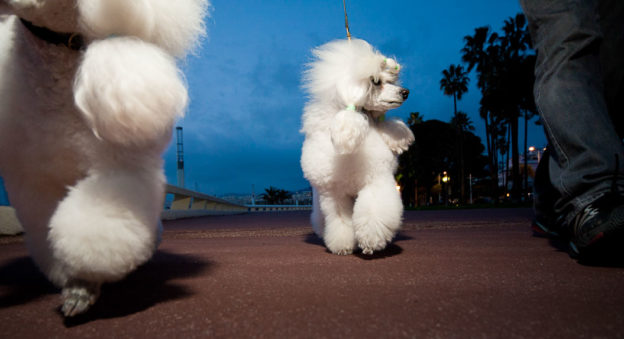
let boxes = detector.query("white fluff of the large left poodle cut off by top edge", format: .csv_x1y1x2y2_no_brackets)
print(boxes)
77,0,210,57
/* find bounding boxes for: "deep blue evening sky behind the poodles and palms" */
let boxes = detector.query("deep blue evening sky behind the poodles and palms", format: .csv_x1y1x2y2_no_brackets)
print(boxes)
164,0,545,195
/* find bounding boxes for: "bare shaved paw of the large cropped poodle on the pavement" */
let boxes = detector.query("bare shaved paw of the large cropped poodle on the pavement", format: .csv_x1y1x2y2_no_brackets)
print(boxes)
61,280,100,317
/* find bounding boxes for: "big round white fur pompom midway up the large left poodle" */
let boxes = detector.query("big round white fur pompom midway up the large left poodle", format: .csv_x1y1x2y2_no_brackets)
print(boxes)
74,37,188,148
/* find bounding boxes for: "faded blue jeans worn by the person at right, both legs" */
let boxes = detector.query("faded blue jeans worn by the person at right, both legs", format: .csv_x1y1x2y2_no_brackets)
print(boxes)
520,0,624,225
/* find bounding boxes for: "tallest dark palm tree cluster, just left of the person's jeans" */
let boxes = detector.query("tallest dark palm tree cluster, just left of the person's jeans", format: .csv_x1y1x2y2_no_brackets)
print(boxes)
461,14,535,199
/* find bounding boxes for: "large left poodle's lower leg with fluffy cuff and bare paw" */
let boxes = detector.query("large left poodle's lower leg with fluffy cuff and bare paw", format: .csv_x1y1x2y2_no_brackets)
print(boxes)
48,168,164,316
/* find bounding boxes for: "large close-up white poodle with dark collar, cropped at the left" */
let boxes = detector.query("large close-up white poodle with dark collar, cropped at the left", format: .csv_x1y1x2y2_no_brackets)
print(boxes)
0,0,209,316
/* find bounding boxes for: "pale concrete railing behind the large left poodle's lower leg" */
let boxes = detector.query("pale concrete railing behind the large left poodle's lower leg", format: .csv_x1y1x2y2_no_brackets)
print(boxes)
161,185,248,220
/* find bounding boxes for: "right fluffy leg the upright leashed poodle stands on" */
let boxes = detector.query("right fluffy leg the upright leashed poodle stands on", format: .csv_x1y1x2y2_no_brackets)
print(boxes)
353,177,403,254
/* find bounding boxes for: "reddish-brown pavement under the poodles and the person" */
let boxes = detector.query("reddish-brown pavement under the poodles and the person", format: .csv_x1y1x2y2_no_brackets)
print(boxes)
0,209,624,338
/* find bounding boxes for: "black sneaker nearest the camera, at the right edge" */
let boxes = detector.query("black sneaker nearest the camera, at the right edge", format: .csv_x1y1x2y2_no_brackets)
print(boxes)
570,194,624,258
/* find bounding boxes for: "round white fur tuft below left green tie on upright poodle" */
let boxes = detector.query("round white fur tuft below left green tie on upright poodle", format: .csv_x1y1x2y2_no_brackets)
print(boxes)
330,105,369,154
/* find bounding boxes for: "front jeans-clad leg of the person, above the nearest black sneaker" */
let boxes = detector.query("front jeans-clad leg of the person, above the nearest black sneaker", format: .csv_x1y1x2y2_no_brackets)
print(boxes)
521,0,624,228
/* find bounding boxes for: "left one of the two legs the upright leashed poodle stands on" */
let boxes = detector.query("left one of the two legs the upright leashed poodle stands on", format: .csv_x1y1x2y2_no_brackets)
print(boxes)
319,194,355,255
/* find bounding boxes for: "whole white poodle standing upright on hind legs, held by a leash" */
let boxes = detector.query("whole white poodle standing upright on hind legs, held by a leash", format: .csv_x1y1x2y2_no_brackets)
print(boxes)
301,39,414,255
